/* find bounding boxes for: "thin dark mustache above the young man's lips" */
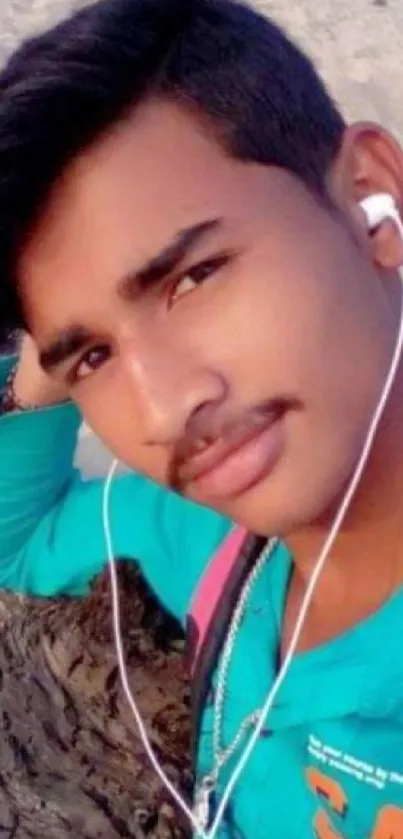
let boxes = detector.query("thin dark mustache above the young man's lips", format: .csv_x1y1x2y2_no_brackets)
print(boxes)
167,397,296,494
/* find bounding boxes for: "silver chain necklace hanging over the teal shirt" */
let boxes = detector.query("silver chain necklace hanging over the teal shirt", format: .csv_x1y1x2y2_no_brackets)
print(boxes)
193,539,278,831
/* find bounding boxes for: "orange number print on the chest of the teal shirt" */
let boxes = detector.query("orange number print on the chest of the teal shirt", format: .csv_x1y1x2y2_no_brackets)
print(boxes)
306,767,403,839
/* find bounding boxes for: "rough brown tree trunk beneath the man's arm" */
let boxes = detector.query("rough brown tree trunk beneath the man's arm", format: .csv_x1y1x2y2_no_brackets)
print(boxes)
0,563,191,839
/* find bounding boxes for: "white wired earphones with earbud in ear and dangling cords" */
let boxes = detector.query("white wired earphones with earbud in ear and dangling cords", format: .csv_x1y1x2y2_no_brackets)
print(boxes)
103,193,403,839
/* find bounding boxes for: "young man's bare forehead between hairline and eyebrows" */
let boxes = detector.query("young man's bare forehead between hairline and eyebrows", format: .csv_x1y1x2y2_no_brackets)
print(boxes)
19,101,312,326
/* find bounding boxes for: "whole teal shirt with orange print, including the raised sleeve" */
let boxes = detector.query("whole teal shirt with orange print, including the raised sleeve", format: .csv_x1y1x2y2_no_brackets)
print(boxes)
0,360,403,839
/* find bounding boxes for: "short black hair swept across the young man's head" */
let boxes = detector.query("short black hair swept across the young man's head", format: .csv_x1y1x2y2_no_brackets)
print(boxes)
0,0,344,332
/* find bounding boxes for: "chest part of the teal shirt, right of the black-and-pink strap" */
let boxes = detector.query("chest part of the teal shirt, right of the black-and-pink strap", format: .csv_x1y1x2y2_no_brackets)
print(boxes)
198,546,403,839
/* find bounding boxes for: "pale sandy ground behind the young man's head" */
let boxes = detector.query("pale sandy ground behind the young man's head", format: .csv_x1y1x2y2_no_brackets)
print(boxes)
0,0,403,473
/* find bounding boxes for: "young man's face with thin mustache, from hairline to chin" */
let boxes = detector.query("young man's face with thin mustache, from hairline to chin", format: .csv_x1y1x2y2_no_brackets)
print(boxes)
20,102,390,533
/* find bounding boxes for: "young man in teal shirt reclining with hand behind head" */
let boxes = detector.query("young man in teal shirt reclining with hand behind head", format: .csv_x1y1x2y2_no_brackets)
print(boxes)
0,0,403,839
